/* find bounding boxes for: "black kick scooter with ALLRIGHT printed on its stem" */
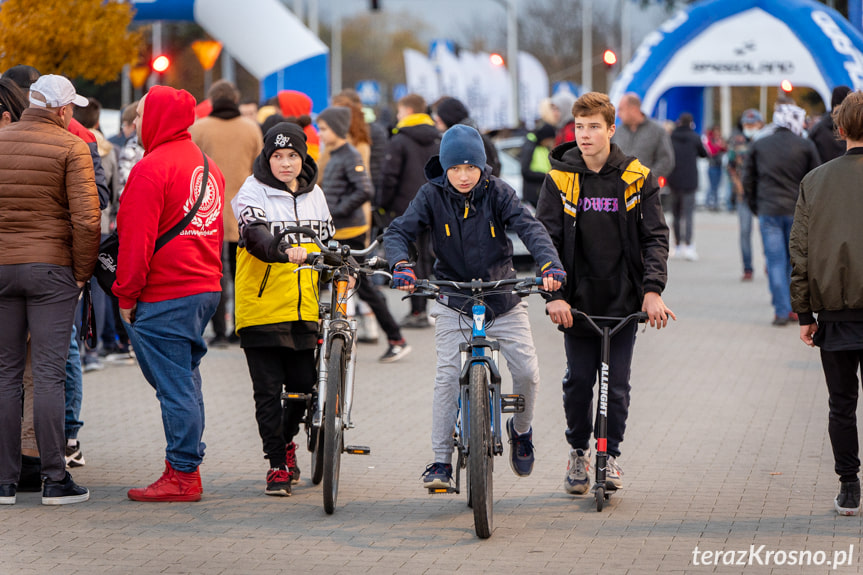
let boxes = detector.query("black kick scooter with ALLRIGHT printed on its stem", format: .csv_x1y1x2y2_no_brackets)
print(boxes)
570,308,648,511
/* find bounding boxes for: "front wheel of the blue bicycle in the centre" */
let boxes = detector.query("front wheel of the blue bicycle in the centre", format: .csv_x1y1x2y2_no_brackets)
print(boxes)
468,364,494,539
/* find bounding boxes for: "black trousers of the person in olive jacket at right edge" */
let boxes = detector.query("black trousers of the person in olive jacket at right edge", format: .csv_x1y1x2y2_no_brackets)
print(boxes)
821,349,863,481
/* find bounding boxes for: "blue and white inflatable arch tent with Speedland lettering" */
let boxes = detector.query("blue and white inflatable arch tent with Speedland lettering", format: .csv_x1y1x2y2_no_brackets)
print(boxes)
610,0,863,122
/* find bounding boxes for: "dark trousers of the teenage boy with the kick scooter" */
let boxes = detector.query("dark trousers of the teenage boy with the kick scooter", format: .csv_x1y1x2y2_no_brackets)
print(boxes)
563,323,638,457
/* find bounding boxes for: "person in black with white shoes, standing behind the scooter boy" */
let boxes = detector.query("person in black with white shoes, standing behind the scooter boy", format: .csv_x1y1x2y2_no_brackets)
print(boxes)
668,112,708,261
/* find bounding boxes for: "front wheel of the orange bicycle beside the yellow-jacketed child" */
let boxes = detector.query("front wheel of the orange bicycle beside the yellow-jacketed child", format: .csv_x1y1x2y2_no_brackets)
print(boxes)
323,338,347,514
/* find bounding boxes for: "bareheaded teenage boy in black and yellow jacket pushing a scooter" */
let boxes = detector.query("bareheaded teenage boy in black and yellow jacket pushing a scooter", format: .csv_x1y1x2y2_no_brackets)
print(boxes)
536,92,677,494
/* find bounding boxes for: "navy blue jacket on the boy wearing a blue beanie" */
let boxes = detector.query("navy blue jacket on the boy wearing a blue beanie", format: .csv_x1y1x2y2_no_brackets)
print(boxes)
384,156,563,314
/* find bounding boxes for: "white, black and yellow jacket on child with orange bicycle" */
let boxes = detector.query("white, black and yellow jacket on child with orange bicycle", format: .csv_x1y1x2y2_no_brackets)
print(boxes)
231,153,335,350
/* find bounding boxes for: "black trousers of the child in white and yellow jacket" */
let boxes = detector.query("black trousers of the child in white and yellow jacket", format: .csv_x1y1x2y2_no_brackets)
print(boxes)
243,347,317,467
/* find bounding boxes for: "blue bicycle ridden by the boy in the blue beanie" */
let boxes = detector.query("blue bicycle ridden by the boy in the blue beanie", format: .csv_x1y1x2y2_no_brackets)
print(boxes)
405,278,542,539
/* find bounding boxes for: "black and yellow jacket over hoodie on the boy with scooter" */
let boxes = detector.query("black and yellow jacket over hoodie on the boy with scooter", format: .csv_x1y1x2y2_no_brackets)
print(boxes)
536,142,668,324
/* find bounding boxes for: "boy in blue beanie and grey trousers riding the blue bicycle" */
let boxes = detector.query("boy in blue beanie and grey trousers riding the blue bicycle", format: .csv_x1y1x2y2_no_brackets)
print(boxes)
384,124,566,488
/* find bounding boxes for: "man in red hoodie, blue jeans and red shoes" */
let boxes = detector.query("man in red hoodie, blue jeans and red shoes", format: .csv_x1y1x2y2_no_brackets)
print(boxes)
113,86,225,501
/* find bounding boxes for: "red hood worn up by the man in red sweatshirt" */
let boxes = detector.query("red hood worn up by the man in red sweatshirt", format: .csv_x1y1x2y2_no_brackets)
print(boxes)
141,86,195,154
